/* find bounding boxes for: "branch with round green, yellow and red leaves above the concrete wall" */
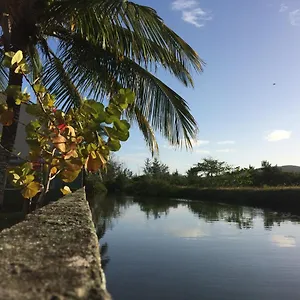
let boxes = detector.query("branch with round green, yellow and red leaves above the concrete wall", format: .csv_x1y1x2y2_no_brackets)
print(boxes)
0,51,135,205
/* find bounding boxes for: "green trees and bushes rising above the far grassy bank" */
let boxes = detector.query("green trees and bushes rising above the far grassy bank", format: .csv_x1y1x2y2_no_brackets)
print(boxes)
96,157,300,196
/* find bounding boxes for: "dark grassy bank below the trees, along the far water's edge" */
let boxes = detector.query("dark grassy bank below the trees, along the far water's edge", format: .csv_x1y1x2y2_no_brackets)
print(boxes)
127,182,300,215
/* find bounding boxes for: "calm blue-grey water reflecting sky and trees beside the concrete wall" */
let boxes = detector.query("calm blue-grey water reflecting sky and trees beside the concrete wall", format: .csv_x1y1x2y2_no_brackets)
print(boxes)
92,198,300,300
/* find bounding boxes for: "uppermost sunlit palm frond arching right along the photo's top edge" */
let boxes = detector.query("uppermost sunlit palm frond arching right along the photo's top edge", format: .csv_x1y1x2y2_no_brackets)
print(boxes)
45,0,204,80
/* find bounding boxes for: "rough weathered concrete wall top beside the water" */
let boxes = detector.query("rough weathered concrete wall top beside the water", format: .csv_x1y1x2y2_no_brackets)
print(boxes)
0,189,111,300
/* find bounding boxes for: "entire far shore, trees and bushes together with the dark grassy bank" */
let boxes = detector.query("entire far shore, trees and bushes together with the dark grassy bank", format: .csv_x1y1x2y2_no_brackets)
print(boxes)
88,158,300,215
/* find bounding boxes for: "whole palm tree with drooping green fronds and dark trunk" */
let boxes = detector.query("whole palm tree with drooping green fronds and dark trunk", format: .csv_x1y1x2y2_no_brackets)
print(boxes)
0,0,203,205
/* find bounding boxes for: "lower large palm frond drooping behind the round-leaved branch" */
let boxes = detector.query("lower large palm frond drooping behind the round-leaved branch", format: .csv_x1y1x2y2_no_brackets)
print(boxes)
48,35,197,147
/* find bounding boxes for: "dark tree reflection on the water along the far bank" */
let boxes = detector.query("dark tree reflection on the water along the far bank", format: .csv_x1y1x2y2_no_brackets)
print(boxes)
90,196,300,238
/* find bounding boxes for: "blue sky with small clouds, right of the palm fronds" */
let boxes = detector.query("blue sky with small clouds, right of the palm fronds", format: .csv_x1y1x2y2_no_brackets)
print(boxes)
117,0,300,173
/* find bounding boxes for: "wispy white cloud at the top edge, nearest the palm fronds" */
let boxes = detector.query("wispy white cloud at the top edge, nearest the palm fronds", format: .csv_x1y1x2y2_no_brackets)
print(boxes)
172,0,212,28
